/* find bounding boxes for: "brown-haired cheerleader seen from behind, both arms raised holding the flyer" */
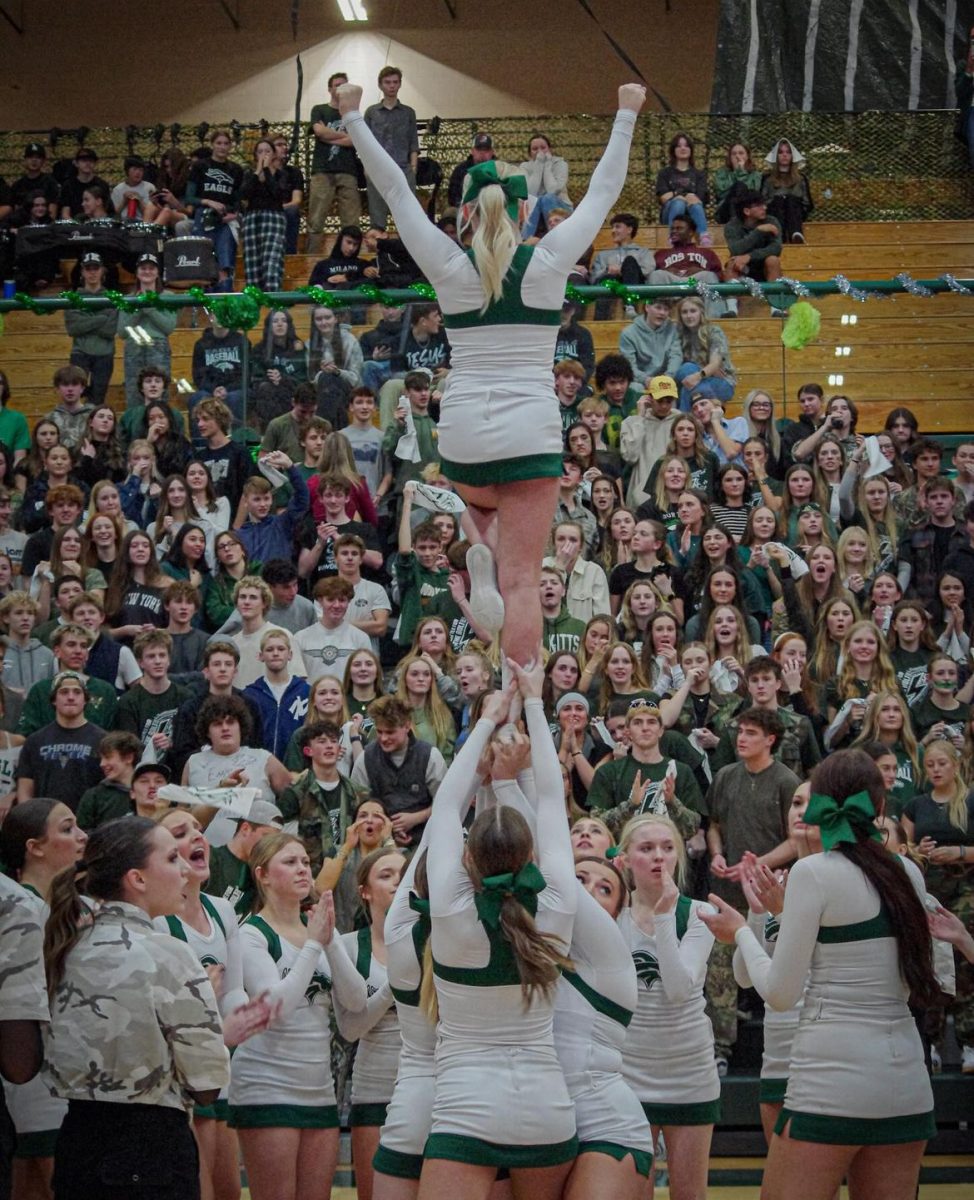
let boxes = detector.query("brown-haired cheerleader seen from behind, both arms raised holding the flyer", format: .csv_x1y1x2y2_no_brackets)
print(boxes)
419,662,577,1200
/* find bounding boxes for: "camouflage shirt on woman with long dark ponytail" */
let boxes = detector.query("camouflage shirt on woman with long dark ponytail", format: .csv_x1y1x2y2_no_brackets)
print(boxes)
44,901,230,1109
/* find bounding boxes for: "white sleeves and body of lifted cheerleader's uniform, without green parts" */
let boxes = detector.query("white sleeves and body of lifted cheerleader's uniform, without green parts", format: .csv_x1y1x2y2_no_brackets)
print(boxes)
344,109,636,463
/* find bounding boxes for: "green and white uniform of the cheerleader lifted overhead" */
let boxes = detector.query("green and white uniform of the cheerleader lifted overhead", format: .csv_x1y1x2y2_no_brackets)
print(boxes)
344,110,636,486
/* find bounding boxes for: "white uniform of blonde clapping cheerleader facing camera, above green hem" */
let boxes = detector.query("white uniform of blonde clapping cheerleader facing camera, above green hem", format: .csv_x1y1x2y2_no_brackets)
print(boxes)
619,901,721,1104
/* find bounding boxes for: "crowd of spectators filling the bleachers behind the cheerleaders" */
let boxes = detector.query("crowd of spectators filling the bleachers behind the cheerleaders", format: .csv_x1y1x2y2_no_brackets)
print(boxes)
0,68,974,1200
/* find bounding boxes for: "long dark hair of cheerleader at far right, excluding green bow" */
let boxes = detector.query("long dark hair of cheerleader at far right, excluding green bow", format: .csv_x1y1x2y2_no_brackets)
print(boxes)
810,750,940,1007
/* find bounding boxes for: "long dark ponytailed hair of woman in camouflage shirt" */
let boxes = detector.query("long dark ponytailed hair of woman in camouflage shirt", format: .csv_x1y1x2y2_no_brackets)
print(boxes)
44,816,156,996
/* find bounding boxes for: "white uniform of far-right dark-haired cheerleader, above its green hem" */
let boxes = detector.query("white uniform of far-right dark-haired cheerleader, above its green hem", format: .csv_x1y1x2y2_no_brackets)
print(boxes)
736,851,933,1118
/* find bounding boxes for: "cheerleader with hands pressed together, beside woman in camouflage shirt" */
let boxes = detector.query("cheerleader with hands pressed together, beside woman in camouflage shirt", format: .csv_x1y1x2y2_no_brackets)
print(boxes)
230,833,367,1200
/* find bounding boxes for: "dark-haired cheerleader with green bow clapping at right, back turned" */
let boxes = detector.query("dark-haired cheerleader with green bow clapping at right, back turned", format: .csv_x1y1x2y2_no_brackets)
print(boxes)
704,750,939,1200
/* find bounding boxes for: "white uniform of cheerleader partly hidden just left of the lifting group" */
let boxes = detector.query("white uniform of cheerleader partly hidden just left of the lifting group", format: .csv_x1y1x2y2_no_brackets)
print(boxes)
335,929,402,1104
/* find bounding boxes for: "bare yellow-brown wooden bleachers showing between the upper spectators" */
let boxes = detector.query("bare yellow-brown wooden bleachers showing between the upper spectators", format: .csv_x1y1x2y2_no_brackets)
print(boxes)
0,221,974,432
